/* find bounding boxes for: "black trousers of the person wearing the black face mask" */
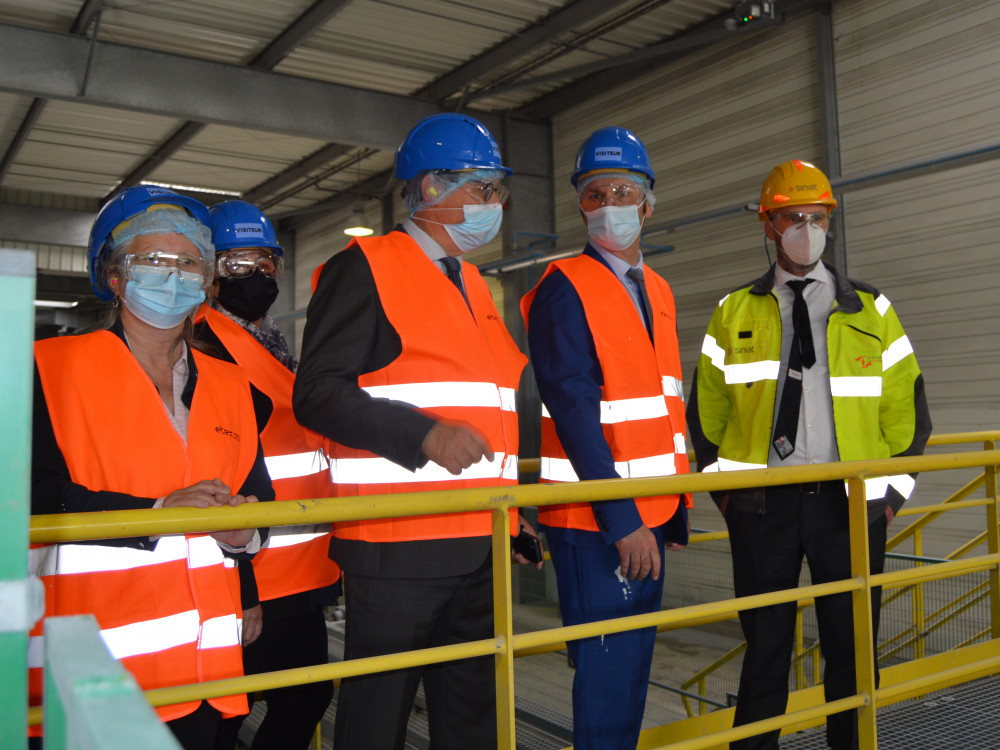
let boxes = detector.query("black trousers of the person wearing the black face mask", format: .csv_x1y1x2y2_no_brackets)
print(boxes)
215,602,333,750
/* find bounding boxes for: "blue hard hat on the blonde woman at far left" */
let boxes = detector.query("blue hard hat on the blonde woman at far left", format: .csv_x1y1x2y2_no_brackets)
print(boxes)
87,185,210,302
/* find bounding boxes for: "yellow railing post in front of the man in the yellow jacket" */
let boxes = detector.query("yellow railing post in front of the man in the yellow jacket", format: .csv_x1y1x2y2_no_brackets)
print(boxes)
848,477,878,750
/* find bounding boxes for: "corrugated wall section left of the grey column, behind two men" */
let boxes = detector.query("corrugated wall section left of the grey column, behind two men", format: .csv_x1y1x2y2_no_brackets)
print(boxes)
553,10,821,412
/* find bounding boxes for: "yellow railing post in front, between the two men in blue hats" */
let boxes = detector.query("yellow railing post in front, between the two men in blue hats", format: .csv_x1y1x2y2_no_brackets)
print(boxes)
492,507,515,750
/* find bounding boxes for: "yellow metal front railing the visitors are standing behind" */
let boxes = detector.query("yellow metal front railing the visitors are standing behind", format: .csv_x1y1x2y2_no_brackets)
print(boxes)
30,433,1000,750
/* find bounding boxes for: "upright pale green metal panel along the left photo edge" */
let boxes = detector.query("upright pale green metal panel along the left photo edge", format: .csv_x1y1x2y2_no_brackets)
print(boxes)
0,249,35,748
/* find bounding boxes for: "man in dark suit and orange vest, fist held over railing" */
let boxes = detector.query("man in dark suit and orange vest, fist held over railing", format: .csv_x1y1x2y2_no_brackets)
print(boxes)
293,114,533,750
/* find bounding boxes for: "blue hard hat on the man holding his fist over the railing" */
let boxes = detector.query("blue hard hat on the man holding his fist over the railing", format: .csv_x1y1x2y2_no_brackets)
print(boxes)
396,112,514,180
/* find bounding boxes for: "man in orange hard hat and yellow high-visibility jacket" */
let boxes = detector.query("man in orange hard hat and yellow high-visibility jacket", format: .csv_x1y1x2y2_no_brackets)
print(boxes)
687,160,931,750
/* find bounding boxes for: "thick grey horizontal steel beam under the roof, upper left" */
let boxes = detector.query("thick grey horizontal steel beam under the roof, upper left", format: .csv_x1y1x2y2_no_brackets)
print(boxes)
0,24,454,149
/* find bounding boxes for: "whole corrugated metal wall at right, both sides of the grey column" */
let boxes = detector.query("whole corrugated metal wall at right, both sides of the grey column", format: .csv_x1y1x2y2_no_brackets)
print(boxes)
554,0,1000,549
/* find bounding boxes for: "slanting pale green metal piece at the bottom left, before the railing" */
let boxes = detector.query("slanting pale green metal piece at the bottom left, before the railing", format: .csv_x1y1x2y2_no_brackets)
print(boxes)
45,615,181,750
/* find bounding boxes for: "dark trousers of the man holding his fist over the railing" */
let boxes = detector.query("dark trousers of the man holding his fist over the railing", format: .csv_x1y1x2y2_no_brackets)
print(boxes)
333,556,497,750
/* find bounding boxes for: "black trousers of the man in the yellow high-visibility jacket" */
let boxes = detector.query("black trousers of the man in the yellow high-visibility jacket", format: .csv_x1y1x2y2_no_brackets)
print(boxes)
725,482,887,750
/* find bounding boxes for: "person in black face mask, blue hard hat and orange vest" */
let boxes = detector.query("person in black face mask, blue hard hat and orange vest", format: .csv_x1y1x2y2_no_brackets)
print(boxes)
195,201,340,750
